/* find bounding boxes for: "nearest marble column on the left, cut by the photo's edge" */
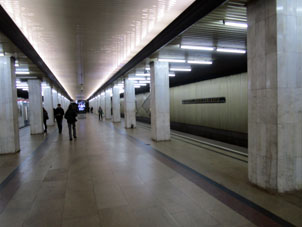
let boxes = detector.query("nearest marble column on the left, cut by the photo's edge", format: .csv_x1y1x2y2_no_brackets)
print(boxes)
0,56,20,154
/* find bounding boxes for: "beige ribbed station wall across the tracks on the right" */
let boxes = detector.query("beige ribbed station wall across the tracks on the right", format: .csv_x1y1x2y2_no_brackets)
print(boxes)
121,73,248,146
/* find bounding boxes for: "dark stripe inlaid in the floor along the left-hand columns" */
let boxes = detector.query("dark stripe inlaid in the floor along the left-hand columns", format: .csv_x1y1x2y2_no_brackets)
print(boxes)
0,130,57,215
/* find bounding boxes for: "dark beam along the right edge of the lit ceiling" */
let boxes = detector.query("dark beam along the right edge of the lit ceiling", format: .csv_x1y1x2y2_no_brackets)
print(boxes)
88,0,226,99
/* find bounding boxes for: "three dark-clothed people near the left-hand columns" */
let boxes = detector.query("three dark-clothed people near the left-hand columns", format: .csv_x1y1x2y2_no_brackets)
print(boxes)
43,103,78,140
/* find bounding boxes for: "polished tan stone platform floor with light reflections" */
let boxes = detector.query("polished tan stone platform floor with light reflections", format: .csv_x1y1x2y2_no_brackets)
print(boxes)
0,115,302,227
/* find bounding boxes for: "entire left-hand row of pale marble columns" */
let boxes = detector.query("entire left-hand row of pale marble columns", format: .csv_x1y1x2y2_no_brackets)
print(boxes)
0,56,70,154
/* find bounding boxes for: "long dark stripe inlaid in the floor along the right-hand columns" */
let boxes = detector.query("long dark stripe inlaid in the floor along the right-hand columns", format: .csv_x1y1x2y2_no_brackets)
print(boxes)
107,123,294,227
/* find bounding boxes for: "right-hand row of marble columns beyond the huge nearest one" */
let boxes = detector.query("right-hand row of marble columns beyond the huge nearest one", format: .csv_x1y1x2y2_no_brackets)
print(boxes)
89,61,170,141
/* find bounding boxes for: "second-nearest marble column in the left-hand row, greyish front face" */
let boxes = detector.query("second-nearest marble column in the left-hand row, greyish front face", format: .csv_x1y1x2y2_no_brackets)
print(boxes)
28,79,44,134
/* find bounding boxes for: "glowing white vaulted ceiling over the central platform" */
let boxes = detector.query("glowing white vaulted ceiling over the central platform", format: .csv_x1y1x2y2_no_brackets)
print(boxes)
0,0,194,99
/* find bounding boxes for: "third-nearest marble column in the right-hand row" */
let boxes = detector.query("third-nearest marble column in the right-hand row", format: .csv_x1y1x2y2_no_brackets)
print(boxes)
124,79,136,128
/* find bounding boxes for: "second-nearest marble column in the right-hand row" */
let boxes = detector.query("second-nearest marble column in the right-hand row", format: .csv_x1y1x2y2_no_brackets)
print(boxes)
150,61,170,141
